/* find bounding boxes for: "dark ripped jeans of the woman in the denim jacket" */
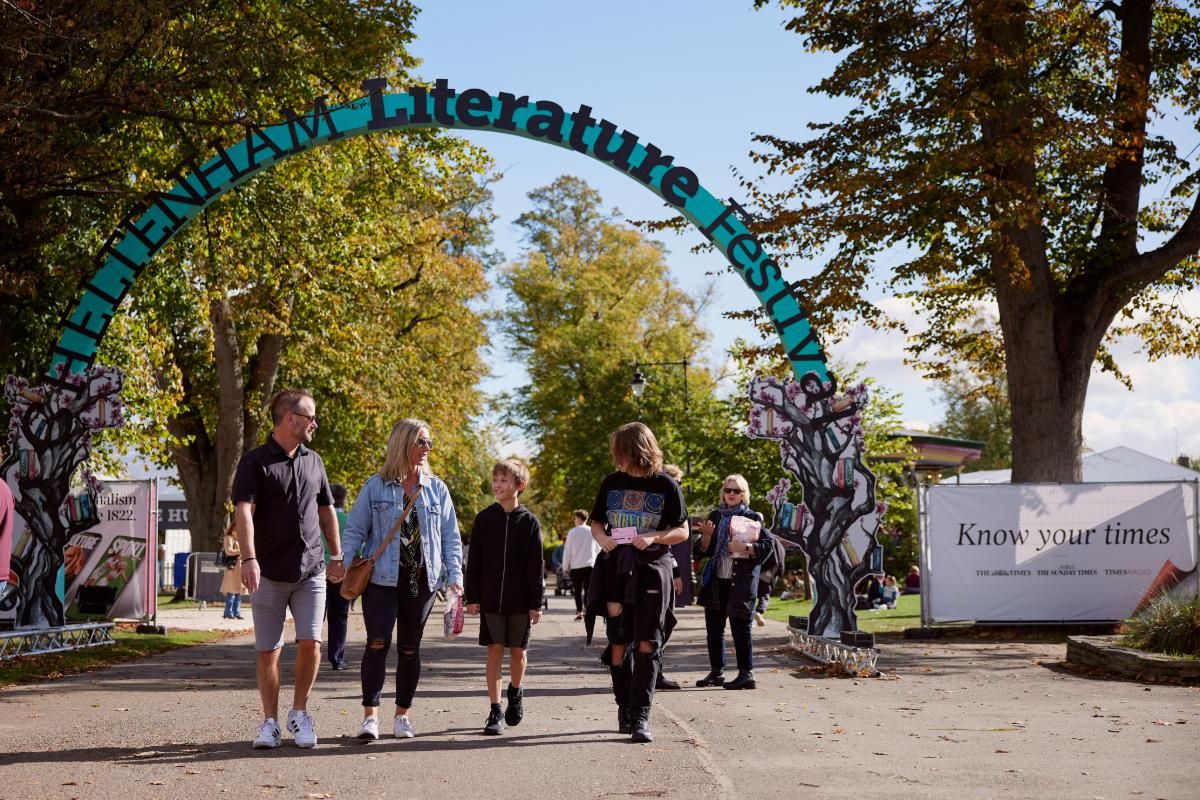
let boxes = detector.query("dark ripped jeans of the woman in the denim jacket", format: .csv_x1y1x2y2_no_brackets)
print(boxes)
360,575,434,709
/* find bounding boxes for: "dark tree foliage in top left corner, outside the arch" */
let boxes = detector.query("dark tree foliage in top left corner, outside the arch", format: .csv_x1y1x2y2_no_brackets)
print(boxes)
0,0,416,377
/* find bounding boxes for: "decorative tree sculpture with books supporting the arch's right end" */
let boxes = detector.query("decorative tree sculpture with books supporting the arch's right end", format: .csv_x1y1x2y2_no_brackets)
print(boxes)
748,374,883,637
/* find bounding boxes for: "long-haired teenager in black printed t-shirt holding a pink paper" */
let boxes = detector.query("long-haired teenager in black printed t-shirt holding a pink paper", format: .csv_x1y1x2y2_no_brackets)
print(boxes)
588,422,688,742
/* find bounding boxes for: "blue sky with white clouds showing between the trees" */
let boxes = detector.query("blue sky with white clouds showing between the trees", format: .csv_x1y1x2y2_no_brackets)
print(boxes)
410,0,1200,458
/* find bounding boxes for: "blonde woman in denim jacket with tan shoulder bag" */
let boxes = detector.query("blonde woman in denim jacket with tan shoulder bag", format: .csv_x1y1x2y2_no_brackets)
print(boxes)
330,420,462,739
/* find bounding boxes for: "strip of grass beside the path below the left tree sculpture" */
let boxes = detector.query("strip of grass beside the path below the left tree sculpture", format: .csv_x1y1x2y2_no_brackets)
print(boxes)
0,628,230,688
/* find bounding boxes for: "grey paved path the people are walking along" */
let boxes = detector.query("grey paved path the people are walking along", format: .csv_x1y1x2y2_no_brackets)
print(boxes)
0,597,1200,800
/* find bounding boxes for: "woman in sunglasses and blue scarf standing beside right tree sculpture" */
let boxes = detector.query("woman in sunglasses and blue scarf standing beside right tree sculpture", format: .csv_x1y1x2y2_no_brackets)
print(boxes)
695,475,773,688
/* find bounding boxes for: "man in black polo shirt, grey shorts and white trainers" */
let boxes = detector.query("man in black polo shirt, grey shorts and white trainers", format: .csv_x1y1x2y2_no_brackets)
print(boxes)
233,389,342,750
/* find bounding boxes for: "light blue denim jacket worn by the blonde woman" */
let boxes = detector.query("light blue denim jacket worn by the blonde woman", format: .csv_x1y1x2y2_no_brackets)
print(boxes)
342,473,462,590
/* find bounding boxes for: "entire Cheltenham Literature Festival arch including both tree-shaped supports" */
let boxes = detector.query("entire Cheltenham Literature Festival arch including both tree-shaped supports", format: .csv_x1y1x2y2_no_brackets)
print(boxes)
0,78,878,636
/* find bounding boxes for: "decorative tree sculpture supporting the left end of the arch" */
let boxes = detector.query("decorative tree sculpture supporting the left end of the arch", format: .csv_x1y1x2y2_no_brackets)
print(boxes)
0,363,124,628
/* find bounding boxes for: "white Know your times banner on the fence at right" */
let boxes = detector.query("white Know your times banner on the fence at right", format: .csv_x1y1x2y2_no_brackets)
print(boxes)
922,483,1196,622
